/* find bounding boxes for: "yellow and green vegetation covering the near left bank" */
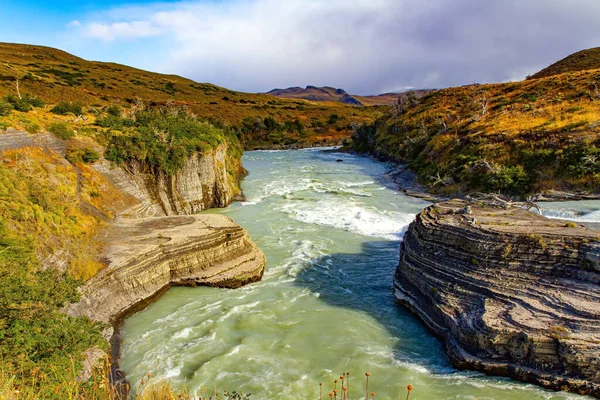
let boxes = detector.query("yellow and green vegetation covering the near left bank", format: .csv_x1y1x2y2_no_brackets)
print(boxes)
0,150,108,398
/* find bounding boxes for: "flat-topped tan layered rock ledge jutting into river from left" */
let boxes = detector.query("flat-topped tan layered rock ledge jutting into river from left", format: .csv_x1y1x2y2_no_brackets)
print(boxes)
65,214,265,326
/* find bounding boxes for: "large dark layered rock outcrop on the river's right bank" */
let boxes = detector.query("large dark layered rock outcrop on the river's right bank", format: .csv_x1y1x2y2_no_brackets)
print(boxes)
394,200,600,397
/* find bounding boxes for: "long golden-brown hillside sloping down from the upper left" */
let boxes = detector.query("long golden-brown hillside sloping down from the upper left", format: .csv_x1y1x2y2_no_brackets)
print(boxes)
0,43,382,148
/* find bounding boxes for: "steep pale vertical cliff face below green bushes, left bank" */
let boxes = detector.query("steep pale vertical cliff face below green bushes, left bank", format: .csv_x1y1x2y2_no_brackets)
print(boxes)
95,144,244,217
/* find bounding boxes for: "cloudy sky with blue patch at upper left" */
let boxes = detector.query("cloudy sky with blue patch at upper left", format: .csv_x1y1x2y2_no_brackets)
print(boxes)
0,0,600,95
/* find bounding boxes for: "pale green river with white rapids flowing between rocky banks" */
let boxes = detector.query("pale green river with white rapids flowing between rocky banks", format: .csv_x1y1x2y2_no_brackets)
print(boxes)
121,149,600,400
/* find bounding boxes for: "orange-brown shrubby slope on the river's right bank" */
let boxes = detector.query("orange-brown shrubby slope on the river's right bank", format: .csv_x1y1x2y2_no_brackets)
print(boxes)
354,70,600,195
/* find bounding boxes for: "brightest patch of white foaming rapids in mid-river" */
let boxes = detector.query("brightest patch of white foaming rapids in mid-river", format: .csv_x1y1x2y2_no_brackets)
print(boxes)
282,200,414,240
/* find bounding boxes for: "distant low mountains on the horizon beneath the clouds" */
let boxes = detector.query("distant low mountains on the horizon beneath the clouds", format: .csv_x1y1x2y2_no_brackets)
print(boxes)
267,86,430,106
